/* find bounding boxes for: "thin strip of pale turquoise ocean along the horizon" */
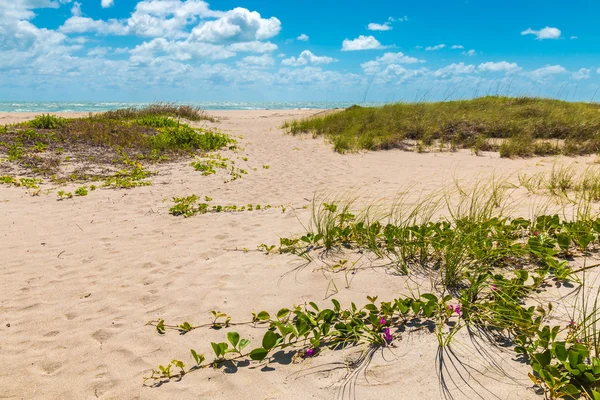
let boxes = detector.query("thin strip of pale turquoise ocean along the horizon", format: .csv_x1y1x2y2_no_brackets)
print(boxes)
0,101,383,113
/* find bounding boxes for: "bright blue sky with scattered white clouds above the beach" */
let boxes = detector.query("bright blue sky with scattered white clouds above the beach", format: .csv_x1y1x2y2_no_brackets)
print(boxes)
0,0,600,103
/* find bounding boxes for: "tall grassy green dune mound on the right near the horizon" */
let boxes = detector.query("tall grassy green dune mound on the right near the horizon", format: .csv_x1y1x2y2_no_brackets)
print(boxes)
284,96,600,157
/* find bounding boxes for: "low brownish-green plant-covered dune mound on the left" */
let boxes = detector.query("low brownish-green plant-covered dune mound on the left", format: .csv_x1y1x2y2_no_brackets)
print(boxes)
0,104,230,184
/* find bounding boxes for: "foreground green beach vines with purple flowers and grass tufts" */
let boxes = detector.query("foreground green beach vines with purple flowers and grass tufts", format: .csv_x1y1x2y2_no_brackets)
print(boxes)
146,181,600,399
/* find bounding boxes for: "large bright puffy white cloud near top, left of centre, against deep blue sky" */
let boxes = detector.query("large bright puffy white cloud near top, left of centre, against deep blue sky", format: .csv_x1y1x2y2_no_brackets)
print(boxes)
190,7,281,43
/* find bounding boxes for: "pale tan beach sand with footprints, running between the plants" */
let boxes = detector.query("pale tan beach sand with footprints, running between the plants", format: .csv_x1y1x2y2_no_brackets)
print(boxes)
0,111,590,400
